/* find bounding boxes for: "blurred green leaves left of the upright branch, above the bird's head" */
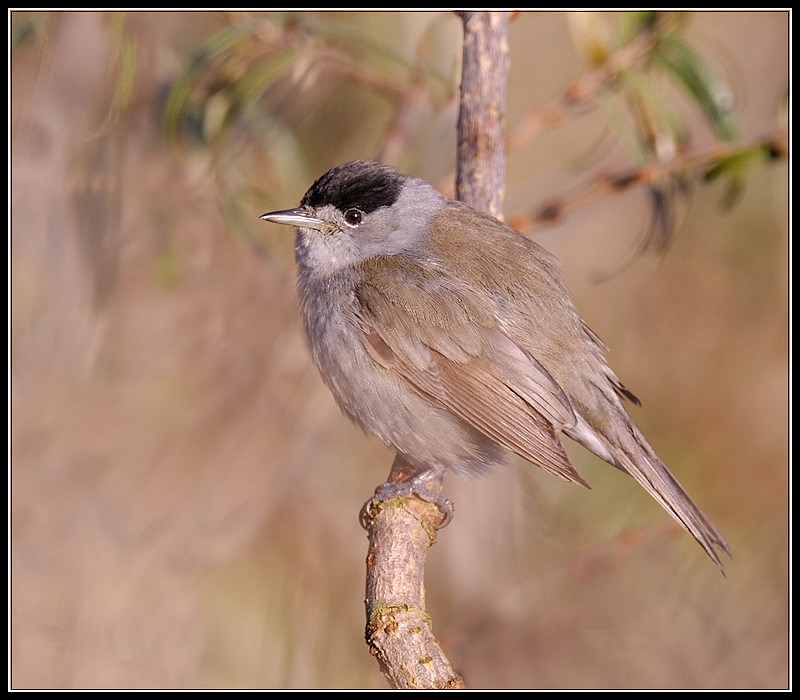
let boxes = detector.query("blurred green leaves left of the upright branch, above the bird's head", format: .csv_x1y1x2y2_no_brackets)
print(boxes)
164,12,454,148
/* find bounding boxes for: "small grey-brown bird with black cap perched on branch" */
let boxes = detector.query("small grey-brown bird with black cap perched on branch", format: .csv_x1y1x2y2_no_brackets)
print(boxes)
260,161,730,570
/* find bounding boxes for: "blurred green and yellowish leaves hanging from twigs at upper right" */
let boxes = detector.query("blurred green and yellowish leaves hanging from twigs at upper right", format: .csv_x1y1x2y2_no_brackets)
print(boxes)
569,11,770,247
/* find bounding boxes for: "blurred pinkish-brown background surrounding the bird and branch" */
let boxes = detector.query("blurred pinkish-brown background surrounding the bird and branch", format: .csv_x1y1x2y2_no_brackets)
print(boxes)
9,12,790,689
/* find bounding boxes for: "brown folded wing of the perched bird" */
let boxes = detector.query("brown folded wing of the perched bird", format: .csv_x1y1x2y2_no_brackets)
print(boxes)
357,257,587,486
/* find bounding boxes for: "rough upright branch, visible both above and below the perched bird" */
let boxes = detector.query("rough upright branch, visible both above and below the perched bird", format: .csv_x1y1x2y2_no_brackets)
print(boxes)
362,11,508,689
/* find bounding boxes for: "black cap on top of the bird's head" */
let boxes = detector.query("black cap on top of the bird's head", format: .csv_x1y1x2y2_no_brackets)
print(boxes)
300,160,404,214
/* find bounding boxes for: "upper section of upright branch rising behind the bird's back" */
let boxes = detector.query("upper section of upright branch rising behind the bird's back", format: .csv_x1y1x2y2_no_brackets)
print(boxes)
456,10,509,218
